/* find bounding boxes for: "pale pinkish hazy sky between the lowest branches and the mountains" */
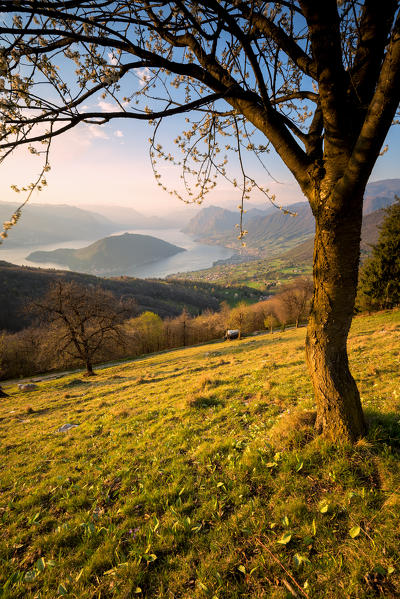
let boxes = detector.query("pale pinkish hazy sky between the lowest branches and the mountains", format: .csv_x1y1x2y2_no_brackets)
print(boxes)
0,106,400,214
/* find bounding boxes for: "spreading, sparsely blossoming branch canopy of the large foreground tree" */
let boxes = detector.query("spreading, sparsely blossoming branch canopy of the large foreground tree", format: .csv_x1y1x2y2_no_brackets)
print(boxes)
0,0,400,232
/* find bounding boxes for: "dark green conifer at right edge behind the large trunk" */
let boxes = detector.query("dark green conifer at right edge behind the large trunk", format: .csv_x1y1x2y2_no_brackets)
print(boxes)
358,197,400,309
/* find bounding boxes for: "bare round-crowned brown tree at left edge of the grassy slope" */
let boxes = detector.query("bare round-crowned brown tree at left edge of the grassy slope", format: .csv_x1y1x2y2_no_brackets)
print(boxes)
27,281,130,376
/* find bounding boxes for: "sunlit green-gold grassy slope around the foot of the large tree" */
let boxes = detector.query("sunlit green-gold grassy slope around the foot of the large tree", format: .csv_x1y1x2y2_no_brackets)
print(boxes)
0,310,400,599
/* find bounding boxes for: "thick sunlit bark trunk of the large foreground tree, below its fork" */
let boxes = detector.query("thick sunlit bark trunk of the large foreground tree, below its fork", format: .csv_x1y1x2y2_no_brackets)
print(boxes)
306,192,366,441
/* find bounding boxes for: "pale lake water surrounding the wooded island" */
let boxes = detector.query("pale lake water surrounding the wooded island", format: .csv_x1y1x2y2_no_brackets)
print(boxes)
0,229,234,279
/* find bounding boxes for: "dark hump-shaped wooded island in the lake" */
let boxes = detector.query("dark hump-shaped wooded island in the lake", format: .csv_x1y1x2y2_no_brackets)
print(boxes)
27,233,185,275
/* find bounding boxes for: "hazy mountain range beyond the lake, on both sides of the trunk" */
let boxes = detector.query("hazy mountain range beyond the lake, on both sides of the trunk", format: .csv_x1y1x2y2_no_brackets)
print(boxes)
0,179,400,259
